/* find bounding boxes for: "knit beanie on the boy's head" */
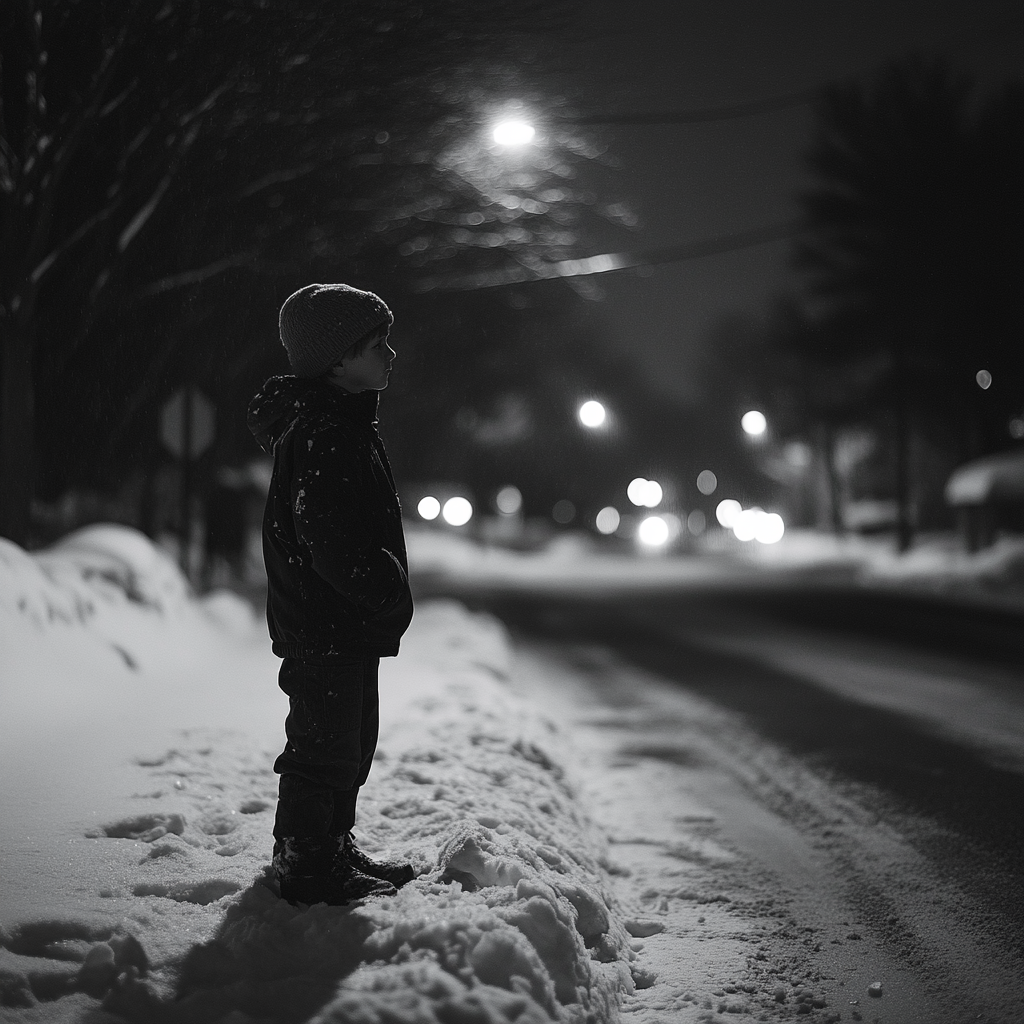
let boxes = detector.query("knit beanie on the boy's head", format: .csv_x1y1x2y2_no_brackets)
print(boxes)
278,285,394,377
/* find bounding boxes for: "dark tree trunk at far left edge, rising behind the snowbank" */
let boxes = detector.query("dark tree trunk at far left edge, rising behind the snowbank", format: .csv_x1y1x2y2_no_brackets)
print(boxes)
0,322,35,547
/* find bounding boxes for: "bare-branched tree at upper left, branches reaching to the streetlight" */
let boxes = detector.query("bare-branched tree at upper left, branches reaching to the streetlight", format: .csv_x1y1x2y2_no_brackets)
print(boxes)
0,0,606,542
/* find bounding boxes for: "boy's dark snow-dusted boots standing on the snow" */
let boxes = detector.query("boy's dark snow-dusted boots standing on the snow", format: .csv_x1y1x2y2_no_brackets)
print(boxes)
273,837,398,906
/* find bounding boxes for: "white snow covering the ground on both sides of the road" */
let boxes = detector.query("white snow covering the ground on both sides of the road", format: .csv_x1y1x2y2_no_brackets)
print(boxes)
0,527,1024,1024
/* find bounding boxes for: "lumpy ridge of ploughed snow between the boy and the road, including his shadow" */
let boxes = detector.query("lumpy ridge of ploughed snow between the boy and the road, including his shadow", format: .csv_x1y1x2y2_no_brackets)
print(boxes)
104,602,653,1024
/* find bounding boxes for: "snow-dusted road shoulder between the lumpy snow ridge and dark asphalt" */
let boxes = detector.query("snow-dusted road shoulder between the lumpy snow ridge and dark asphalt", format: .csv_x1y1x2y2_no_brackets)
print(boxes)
505,641,1014,1024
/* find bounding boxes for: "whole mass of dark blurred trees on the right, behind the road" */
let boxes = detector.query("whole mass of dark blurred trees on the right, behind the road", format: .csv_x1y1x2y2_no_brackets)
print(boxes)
720,56,1024,550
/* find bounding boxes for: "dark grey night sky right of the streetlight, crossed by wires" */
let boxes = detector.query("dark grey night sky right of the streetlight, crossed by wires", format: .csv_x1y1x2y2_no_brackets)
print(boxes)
544,0,1024,407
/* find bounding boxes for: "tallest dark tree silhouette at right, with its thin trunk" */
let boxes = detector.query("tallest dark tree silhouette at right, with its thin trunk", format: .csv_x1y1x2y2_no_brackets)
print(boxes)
797,57,1024,550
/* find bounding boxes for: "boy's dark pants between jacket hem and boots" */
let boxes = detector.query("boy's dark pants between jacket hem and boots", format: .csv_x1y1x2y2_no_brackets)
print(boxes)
273,657,380,839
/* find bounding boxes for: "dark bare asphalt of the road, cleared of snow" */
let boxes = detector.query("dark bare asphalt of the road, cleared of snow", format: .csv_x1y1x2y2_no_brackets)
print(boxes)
417,585,1024,963
